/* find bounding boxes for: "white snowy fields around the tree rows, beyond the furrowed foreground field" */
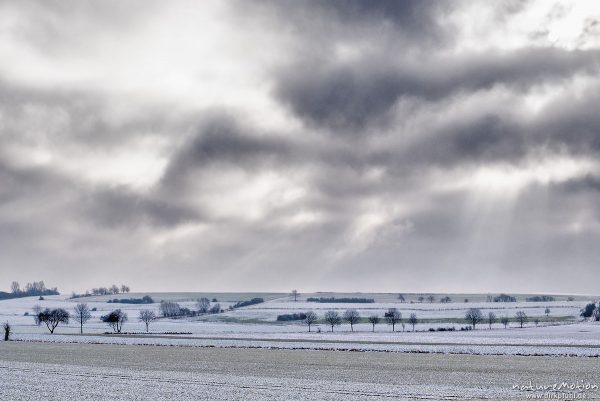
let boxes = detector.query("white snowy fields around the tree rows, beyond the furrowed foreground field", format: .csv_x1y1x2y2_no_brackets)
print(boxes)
0,296,600,356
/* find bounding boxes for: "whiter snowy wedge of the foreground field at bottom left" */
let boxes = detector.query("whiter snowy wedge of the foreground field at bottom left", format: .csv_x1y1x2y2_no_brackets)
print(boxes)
0,362,515,401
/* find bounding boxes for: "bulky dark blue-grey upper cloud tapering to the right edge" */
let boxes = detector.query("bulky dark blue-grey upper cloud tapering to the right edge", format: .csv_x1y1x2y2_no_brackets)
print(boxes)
276,48,600,130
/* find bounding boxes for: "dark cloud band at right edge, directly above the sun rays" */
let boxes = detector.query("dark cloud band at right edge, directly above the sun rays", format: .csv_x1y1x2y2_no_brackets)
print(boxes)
367,80,600,174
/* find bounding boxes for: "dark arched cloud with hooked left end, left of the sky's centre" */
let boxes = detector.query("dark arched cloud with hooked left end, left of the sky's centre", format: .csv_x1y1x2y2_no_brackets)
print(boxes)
161,111,386,194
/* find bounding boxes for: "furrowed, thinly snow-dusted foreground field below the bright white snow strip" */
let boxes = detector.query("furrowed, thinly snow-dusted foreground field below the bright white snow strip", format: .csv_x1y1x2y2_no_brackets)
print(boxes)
0,342,599,401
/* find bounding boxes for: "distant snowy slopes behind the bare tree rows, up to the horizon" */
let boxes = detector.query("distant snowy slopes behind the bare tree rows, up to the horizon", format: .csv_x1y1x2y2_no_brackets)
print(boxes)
0,295,594,326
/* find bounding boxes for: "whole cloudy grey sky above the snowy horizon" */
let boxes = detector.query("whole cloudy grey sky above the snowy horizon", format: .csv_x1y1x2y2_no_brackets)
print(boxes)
0,0,600,293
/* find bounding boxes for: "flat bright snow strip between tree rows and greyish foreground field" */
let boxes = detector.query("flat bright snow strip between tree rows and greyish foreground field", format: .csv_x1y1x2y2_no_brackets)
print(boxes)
14,326,600,357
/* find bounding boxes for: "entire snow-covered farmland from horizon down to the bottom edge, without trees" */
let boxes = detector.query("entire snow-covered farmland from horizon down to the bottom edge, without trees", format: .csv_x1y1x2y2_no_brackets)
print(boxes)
0,294,600,401
